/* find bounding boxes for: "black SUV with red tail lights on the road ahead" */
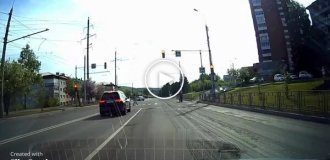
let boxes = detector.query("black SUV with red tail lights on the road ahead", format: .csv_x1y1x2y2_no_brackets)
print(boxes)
99,91,131,116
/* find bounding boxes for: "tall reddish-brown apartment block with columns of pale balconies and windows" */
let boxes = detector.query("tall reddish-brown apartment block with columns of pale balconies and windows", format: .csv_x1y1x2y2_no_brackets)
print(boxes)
249,0,294,76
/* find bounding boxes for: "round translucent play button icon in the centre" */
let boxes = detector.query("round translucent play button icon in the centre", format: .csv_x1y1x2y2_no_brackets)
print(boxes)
144,58,184,99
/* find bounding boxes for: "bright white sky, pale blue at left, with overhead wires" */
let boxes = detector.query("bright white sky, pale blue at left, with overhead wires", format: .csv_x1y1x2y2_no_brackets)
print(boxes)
0,0,314,87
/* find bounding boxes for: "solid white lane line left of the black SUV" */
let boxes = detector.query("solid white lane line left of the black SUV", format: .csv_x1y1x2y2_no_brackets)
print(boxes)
0,113,99,145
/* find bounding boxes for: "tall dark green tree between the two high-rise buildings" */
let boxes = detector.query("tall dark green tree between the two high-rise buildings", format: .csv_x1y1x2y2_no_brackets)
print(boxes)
283,0,330,77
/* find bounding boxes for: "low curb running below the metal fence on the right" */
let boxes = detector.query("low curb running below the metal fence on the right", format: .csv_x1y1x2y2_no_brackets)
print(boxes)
197,101,330,124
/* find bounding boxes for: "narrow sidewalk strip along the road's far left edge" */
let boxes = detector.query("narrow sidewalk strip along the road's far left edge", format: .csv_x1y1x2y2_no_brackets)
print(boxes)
4,104,95,118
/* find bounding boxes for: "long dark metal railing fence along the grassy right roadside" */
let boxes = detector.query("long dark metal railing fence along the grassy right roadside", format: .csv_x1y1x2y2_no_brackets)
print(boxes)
199,91,330,117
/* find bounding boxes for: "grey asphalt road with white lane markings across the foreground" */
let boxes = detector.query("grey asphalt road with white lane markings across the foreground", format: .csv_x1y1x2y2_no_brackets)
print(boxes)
0,98,330,160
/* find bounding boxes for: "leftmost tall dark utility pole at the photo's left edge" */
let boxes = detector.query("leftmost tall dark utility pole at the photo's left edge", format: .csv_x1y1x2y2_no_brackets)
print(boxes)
0,7,13,118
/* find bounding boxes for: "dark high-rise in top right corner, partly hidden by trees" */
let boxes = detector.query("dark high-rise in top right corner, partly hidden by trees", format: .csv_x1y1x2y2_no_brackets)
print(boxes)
307,0,330,54
